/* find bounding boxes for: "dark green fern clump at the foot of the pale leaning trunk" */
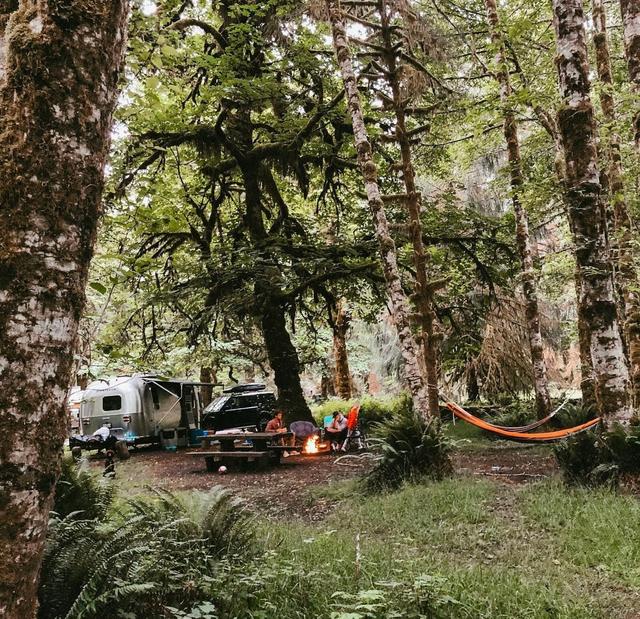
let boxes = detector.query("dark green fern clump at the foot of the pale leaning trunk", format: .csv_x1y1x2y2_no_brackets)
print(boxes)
363,399,452,492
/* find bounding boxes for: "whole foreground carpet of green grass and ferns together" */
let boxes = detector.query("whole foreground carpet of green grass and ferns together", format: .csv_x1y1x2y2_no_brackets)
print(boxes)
41,458,640,619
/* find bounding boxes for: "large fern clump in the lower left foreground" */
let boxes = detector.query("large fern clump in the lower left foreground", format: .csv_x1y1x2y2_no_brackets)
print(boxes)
38,487,254,619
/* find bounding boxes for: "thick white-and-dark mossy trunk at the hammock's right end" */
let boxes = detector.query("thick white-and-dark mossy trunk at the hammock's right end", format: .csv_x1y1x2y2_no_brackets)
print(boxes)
553,0,631,423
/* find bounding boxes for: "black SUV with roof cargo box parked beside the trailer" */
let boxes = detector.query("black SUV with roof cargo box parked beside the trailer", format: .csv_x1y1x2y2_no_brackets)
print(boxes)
201,383,276,432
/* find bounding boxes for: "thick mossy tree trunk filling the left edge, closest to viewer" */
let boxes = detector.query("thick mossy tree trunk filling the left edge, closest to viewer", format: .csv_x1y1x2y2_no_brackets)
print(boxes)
0,0,127,619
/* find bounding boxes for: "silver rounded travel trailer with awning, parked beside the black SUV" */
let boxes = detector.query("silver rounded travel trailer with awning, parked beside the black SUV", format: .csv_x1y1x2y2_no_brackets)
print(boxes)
79,374,202,446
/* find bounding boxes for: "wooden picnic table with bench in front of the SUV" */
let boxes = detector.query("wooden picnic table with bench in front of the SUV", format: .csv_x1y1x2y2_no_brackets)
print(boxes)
187,432,293,471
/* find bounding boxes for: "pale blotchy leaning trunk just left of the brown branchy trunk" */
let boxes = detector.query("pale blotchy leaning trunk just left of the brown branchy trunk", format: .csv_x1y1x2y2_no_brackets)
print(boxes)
327,0,431,418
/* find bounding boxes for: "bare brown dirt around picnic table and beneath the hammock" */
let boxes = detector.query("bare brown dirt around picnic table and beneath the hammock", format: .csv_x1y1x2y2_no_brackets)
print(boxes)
90,443,557,522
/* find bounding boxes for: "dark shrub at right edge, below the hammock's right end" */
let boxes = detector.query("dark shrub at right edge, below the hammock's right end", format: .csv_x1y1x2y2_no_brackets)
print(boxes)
554,424,640,486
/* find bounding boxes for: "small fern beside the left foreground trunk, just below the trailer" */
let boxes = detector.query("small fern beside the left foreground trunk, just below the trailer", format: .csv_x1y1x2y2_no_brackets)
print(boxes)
53,458,114,520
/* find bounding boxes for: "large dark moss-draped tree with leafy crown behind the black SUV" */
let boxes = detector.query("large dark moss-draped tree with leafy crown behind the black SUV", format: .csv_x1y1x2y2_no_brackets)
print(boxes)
115,0,379,420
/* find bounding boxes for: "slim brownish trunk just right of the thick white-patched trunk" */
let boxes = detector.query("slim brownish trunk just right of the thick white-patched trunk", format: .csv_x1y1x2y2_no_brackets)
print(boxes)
592,0,640,407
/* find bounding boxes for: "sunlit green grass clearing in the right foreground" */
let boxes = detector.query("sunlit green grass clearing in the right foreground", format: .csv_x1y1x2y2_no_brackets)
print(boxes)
258,478,640,619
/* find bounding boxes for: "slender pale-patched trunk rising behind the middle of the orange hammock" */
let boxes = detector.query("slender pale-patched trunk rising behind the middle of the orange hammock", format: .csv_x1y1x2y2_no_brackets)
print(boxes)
485,0,551,419
